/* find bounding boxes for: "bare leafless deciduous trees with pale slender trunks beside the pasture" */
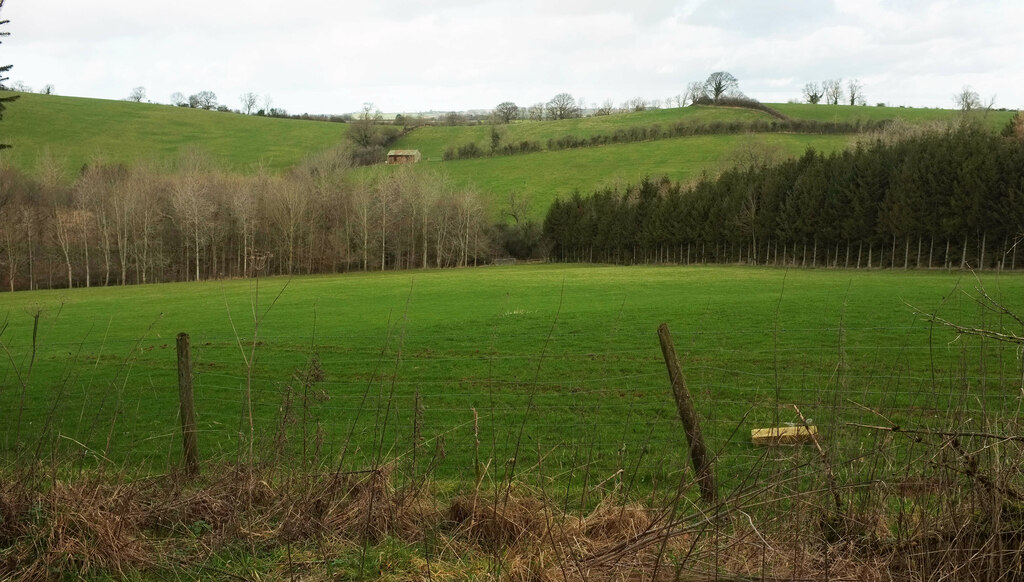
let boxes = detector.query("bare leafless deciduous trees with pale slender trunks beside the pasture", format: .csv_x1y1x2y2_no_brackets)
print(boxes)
0,149,493,291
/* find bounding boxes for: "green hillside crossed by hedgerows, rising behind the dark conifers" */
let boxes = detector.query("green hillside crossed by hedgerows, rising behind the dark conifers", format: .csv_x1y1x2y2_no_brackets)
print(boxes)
385,103,1013,219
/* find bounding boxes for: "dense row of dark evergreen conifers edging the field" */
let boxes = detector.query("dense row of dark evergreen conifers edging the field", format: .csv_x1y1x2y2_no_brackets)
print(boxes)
544,124,1024,268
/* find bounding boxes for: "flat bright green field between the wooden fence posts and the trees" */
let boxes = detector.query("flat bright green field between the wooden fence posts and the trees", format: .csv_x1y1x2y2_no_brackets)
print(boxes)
0,265,1024,497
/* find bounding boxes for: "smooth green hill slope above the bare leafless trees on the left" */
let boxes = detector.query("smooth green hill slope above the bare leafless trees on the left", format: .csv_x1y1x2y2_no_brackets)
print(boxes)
0,92,347,177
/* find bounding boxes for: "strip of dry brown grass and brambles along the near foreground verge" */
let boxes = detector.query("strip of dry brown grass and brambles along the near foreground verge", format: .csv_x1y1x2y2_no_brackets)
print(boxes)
0,439,1024,582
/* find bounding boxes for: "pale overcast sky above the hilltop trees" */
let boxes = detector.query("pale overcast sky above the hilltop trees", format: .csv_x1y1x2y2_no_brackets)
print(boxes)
0,0,1024,114
